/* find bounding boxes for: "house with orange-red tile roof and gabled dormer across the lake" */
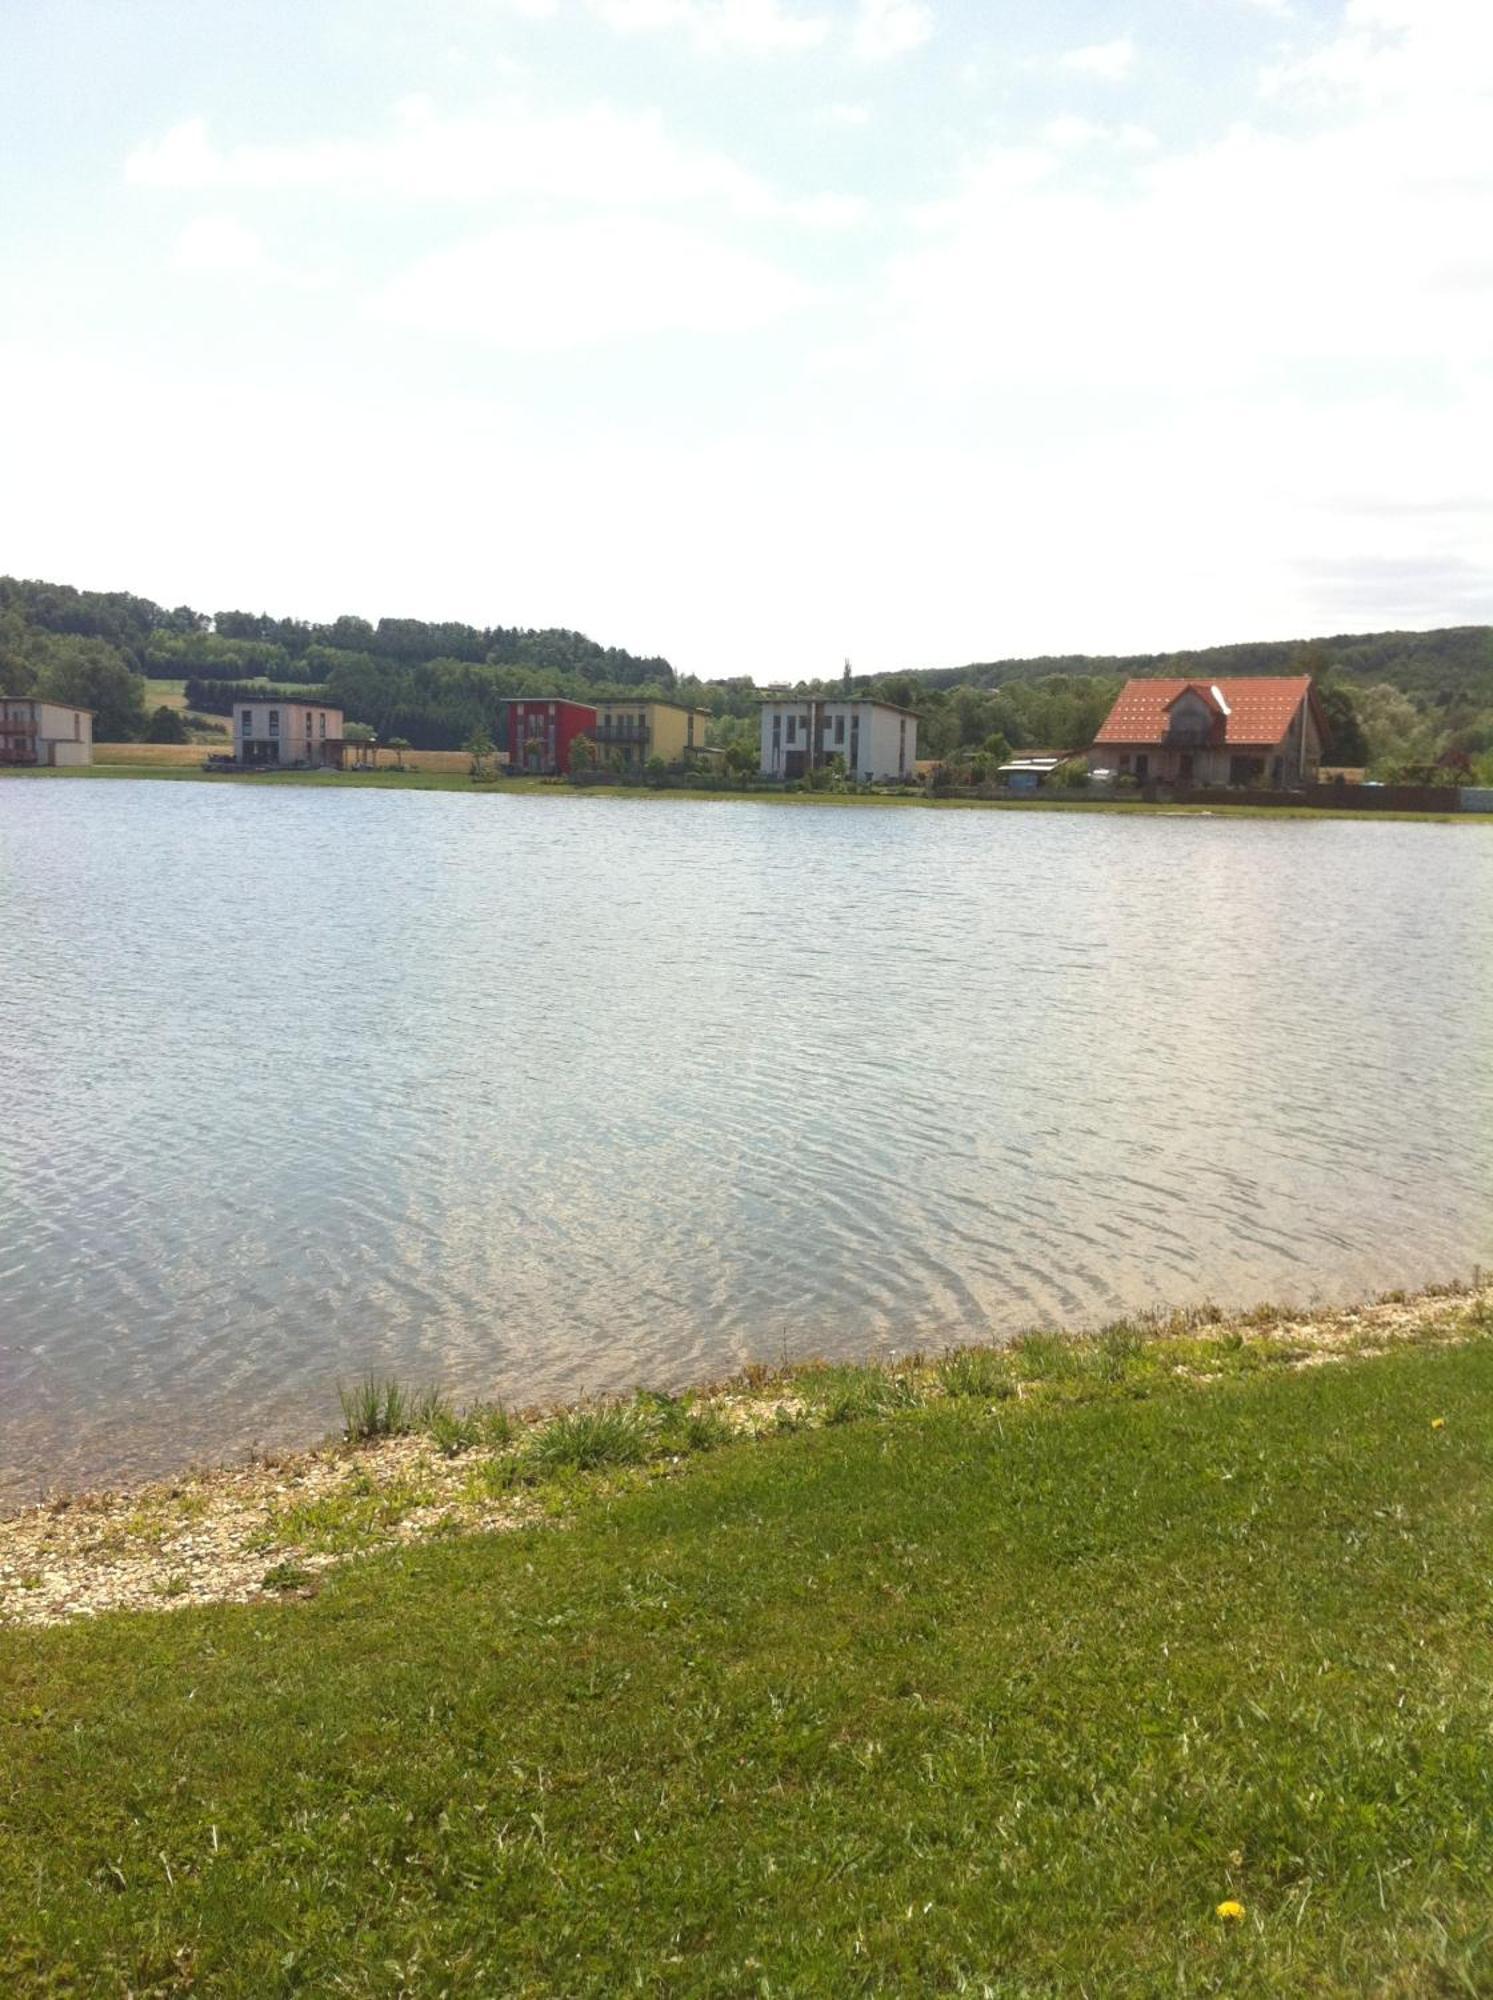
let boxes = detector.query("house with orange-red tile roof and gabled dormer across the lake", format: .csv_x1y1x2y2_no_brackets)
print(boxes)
1089,674,1327,790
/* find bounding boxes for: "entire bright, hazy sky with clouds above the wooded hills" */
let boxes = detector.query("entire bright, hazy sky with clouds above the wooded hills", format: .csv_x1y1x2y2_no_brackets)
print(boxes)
0,0,1493,680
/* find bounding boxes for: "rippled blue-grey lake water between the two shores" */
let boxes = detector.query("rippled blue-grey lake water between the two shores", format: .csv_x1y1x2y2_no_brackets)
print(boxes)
0,780,1493,1500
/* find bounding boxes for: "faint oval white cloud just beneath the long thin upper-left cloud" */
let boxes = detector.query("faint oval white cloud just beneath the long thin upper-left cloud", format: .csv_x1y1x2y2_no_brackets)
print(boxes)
372,216,815,352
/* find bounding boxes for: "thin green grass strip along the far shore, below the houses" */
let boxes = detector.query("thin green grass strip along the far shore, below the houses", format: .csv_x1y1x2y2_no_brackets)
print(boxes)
0,762,1493,826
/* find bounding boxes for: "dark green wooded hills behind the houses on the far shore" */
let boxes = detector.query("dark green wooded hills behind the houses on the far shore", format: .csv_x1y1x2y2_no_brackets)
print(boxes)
0,576,1493,782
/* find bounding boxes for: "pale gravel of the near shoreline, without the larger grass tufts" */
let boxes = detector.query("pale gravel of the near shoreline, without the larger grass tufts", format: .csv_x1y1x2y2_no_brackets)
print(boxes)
0,1280,1493,1626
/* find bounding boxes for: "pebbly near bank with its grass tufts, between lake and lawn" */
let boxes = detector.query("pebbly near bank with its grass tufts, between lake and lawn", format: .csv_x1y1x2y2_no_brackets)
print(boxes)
0,1274,1493,1626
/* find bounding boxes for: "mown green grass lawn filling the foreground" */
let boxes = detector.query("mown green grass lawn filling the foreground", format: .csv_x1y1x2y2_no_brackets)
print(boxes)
0,1336,1493,2000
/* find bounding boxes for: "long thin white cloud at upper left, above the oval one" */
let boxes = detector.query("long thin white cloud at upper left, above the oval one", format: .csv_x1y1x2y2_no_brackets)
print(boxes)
124,98,861,228
